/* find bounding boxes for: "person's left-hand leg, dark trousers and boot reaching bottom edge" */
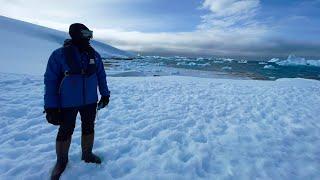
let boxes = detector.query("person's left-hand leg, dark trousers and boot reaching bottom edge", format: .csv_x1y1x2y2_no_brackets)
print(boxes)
51,109,78,180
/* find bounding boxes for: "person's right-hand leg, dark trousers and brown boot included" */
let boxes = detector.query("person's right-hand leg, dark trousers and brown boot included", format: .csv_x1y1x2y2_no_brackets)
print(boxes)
80,104,101,164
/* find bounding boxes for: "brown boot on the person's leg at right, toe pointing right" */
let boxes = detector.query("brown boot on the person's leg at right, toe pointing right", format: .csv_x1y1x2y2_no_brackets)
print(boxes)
81,134,101,164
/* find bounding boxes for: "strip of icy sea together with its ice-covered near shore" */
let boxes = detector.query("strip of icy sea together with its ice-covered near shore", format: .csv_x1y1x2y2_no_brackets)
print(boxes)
104,56,320,80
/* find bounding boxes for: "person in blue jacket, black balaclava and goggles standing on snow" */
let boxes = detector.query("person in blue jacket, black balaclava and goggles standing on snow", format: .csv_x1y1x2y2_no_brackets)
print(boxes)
44,23,110,179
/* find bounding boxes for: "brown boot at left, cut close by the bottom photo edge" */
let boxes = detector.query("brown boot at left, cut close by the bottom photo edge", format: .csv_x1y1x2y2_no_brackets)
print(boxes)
51,139,71,180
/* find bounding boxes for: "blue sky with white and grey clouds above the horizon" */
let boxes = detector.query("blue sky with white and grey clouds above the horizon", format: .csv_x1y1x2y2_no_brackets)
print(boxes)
0,0,320,57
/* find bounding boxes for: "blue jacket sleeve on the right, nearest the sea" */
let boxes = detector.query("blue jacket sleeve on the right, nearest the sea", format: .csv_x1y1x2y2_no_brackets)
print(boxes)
96,53,110,96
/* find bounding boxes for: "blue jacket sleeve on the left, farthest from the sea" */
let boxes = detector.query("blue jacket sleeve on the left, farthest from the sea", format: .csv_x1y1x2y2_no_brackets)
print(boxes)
44,51,61,108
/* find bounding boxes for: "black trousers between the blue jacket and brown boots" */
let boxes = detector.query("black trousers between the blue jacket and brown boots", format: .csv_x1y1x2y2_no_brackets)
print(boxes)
57,103,97,141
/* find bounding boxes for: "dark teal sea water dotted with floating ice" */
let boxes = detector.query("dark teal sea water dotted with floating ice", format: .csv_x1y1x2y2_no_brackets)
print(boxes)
106,56,320,80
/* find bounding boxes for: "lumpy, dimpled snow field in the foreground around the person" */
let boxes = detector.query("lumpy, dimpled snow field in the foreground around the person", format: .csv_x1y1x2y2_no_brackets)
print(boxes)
0,73,320,180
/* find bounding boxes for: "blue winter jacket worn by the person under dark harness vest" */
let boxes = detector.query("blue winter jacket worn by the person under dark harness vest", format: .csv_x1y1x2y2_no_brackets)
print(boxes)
44,45,110,108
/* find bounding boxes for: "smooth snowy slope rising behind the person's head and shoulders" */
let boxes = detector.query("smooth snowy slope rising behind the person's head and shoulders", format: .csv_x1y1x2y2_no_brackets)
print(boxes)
0,16,132,75
